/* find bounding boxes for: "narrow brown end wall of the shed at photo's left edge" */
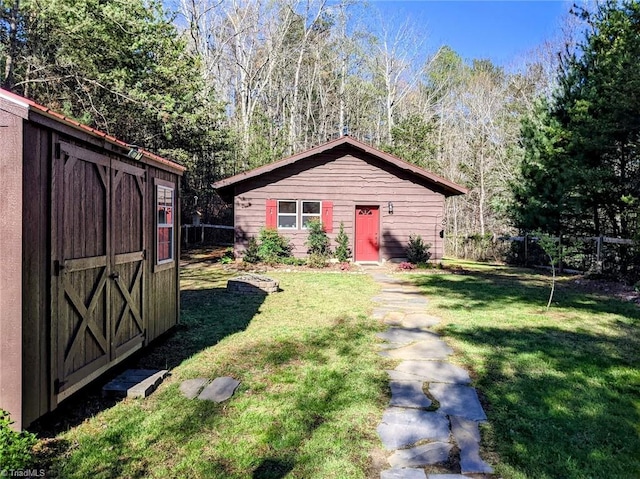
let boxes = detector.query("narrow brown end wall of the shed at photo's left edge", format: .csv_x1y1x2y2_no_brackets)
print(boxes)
0,107,23,428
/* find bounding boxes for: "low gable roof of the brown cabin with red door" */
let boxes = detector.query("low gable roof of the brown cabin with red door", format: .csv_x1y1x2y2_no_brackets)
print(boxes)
213,136,469,197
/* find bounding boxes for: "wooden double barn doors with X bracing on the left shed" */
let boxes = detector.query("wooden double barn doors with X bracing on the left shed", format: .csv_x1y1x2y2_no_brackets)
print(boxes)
51,142,146,399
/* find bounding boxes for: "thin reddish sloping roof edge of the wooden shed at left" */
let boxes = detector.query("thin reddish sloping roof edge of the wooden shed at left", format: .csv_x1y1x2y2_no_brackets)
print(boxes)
0,88,186,174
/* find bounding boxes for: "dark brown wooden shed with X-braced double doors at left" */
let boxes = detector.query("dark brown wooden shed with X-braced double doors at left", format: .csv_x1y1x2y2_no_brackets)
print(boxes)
0,90,184,428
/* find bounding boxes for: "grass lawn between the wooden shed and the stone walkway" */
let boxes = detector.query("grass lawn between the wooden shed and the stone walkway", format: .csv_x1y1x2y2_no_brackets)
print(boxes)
43,266,388,479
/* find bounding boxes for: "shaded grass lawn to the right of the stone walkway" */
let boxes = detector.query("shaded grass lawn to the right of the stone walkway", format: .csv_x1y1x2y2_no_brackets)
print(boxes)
411,263,640,479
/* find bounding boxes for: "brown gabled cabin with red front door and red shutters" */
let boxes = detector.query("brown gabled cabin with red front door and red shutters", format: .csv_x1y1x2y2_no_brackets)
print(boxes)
213,136,467,262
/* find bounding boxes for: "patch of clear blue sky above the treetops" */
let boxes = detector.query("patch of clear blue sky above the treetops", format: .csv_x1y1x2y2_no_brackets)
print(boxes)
370,0,573,65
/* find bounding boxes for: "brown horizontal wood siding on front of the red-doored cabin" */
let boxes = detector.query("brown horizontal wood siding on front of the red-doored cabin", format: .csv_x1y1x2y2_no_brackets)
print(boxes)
234,153,444,260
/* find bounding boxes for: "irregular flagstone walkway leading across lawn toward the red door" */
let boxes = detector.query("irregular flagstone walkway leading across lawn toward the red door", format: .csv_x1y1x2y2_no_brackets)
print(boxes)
372,272,493,479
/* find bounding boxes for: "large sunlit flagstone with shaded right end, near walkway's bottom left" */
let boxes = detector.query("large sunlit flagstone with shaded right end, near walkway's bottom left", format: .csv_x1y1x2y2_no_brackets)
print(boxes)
377,407,449,450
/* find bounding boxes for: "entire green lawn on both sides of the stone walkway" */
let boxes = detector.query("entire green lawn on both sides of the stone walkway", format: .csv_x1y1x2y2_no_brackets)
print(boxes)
38,263,640,479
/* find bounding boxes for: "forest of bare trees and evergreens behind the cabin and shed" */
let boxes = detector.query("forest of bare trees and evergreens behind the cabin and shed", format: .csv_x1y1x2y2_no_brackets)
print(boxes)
0,0,640,284
